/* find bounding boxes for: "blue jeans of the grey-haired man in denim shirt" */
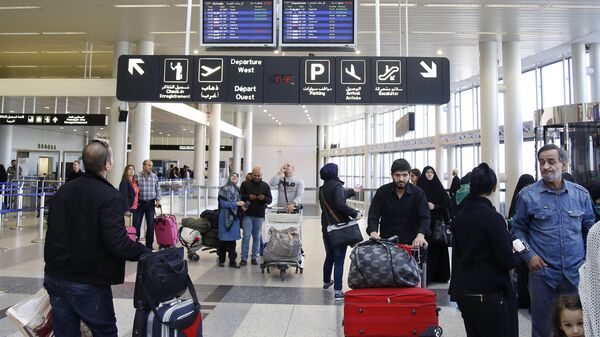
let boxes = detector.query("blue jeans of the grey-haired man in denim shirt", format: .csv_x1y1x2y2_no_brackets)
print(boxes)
529,271,577,337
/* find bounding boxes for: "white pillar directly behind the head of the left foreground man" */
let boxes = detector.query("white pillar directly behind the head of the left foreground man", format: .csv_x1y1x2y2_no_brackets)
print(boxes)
108,41,131,186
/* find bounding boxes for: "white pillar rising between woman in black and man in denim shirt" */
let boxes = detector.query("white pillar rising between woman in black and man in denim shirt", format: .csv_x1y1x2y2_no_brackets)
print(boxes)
502,41,523,214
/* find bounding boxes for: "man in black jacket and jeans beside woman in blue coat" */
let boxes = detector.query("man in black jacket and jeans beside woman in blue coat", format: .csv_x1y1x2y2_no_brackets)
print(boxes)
240,166,273,266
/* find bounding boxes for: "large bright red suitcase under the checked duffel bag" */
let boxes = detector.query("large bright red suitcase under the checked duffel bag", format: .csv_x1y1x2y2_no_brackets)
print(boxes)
344,288,442,337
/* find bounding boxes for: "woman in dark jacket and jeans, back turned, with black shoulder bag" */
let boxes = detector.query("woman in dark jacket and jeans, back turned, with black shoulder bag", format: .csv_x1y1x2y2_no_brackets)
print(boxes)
319,163,362,301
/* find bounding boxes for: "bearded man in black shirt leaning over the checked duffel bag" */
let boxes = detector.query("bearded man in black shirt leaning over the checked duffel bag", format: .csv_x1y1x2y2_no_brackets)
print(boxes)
367,159,431,247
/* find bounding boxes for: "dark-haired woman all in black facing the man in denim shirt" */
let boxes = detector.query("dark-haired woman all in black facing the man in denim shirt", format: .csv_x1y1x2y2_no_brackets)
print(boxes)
450,163,518,337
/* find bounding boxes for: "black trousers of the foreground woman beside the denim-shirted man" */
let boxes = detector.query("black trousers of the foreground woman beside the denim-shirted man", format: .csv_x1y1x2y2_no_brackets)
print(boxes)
457,292,512,337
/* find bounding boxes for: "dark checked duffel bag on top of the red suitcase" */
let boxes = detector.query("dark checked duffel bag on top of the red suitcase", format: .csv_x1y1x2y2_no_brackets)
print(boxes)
348,239,421,289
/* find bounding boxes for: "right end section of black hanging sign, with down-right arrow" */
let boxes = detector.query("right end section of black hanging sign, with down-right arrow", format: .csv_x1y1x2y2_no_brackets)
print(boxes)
406,57,450,104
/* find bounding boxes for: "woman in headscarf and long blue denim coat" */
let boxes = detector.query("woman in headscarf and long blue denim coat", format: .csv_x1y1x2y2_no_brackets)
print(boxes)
217,173,244,268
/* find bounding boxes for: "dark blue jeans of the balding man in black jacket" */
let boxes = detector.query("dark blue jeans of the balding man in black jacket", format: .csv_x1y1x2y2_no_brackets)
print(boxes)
44,275,118,337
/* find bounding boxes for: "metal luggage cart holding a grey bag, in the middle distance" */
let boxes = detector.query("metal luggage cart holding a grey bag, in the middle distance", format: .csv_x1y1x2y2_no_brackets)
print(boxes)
260,207,304,281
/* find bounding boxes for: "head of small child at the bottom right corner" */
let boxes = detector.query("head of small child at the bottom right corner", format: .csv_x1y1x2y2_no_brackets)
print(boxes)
552,295,584,337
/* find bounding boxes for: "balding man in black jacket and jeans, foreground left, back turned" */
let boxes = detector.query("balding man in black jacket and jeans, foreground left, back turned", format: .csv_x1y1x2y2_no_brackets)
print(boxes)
44,141,149,337
